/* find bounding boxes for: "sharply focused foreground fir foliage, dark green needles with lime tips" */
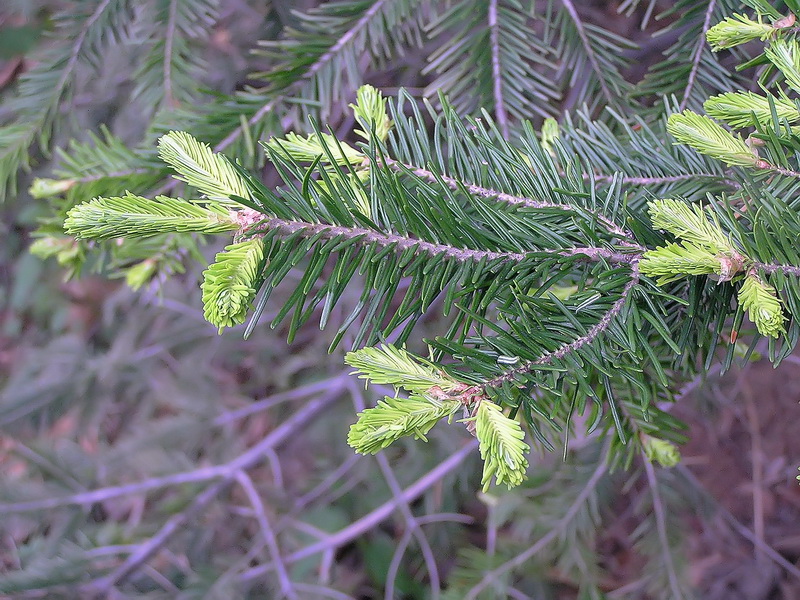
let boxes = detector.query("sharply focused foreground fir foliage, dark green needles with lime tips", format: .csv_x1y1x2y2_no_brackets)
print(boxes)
45,0,800,485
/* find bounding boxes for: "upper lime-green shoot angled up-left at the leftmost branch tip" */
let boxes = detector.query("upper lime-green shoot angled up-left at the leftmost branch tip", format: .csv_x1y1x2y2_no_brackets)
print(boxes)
158,131,250,203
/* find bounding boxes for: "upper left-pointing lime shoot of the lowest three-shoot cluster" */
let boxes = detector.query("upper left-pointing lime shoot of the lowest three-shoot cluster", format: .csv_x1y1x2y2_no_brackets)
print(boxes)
344,344,463,395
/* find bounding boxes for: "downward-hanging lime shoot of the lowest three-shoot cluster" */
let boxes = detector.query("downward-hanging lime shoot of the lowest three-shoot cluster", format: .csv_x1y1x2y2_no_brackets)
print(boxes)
474,400,529,492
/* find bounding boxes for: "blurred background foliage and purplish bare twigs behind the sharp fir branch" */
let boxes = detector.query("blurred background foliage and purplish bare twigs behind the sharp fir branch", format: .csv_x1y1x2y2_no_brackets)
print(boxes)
0,0,800,600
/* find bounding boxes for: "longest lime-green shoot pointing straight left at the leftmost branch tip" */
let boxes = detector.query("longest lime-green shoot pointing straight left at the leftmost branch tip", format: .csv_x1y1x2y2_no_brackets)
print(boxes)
64,193,239,240
